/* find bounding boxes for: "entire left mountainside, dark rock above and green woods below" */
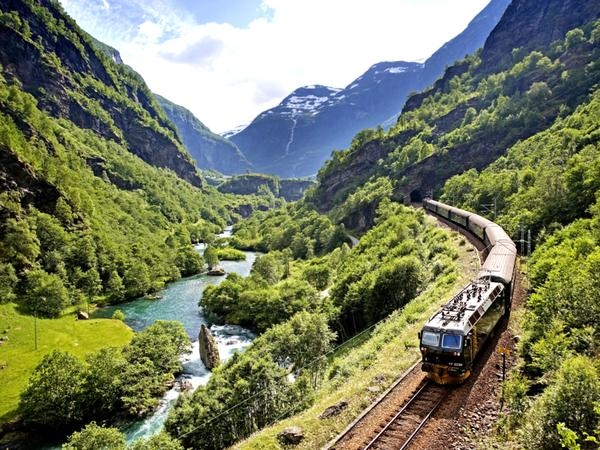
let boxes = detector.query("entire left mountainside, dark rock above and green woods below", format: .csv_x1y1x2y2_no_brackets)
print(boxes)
0,0,248,317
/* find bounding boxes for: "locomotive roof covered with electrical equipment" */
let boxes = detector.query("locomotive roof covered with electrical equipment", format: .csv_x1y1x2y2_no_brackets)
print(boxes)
424,278,504,336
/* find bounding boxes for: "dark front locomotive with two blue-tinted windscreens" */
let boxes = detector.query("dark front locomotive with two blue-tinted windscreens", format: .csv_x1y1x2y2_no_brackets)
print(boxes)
419,278,507,384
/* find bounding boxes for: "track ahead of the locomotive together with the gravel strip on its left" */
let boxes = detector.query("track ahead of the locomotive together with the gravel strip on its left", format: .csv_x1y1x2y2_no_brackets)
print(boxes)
325,363,449,450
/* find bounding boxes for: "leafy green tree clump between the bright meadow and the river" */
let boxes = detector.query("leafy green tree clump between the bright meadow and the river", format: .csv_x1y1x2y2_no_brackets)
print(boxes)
19,321,190,434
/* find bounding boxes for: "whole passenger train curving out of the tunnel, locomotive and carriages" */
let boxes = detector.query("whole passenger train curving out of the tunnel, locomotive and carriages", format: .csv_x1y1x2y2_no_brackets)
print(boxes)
418,199,517,384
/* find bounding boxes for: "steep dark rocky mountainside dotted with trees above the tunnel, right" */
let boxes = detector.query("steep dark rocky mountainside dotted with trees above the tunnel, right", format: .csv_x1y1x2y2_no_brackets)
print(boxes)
312,0,600,228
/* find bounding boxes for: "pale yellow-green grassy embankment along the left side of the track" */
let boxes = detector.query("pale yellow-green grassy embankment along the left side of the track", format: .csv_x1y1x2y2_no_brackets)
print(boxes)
233,222,479,450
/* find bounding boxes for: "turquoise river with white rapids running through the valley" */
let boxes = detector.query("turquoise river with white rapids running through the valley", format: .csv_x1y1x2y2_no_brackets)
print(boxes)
93,244,256,443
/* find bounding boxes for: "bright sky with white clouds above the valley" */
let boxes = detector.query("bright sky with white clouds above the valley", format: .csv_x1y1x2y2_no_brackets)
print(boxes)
60,0,489,133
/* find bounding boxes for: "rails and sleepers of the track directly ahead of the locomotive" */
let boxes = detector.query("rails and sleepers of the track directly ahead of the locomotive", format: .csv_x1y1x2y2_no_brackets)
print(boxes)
363,379,448,450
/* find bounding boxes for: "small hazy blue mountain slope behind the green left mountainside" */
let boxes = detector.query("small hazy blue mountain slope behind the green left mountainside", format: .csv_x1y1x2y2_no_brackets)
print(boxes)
156,95,252,175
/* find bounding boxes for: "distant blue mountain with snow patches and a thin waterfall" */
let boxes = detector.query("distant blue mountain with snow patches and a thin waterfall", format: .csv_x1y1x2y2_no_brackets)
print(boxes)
228,0,510,177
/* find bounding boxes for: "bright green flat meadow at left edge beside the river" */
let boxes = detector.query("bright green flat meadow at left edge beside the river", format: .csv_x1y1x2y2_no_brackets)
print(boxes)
0,304,133,424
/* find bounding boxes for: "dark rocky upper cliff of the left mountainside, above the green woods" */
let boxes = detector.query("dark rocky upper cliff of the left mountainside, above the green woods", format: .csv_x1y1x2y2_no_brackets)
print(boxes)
0,0,202,186
